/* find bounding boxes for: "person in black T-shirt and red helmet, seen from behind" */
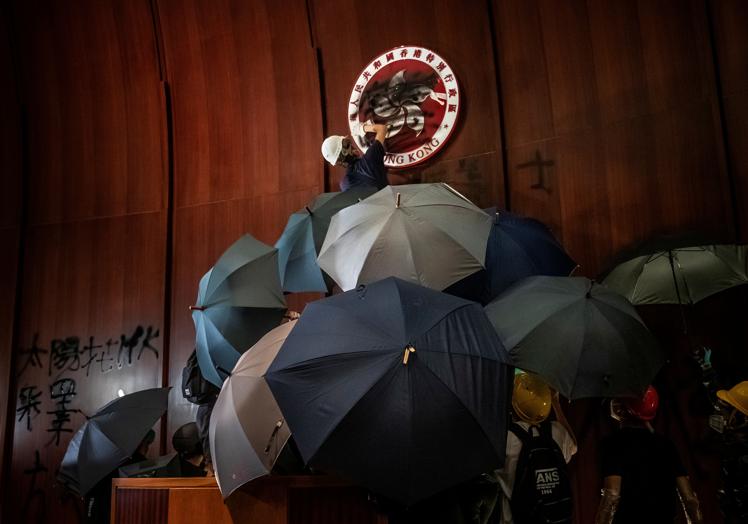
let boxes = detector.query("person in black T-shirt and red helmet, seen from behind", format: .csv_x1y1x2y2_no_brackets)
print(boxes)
595,386,703,524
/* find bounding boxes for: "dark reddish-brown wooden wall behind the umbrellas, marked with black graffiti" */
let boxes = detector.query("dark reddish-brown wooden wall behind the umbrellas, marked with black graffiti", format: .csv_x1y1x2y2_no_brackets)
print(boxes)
0,0,748,522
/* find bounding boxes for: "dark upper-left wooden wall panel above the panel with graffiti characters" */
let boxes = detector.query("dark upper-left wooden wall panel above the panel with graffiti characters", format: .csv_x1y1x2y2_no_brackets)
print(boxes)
14,0,166,224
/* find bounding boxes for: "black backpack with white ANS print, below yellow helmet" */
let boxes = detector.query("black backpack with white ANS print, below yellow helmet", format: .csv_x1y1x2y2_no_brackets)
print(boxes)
509,421,572,524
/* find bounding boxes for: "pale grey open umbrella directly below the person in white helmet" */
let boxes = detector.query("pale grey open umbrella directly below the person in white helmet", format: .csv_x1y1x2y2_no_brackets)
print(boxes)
317,184,491,290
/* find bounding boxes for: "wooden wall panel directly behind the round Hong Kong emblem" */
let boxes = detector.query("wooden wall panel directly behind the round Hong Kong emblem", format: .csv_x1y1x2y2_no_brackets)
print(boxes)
311,0,504,206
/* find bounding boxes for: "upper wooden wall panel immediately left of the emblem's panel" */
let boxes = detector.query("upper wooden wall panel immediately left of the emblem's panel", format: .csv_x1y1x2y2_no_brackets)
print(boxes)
158,0,322,207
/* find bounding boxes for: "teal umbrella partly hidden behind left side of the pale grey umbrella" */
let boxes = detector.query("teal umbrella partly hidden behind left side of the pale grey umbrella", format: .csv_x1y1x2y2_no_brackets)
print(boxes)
275,188,376,293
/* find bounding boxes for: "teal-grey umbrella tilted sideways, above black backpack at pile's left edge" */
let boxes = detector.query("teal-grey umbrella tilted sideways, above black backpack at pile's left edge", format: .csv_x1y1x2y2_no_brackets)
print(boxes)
190,235,286,387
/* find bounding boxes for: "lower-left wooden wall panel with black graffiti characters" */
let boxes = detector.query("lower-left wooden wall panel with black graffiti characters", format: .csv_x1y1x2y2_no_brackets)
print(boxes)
5,212,166,522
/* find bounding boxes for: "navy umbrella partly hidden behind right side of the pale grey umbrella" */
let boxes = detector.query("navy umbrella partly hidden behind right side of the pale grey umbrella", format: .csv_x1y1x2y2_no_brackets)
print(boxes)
445,208,577,304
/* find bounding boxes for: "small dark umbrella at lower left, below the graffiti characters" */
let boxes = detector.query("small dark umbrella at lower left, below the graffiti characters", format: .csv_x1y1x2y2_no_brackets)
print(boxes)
58,388,169,495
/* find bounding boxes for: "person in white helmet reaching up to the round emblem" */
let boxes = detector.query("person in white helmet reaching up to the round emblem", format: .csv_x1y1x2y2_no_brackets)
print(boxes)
322,122,389,191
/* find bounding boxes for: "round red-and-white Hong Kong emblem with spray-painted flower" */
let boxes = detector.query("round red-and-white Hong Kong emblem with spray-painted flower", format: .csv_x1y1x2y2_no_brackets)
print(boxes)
348,46,460,168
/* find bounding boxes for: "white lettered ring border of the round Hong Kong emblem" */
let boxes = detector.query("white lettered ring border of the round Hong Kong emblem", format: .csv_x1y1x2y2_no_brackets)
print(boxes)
347,45,460,169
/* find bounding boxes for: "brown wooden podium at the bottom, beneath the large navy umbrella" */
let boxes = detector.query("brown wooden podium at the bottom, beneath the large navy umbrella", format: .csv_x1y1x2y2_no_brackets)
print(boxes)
111,475,388,524
